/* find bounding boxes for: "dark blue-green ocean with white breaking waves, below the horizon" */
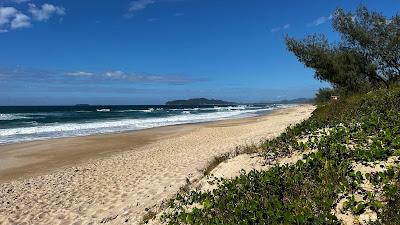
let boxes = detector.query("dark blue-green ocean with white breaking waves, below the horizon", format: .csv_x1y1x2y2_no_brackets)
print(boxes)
0,104,289,144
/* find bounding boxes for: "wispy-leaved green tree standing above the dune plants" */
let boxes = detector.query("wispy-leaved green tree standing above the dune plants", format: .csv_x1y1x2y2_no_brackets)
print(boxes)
286,7,400,94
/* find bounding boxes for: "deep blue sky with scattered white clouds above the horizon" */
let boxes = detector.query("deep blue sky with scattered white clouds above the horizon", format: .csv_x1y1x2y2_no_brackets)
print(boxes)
0,0,400,105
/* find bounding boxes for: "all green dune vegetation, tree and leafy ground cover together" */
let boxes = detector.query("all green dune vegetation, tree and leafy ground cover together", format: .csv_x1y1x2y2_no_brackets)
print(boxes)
157,7,400,224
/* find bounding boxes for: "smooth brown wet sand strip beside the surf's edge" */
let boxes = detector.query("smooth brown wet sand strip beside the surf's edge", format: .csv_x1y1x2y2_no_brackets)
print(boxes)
0,105,288,184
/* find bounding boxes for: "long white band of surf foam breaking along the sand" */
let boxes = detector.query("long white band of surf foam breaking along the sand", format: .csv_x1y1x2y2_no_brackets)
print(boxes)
0,106,290,143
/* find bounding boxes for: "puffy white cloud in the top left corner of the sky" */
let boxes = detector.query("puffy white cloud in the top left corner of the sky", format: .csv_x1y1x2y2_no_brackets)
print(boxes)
0,0,65,33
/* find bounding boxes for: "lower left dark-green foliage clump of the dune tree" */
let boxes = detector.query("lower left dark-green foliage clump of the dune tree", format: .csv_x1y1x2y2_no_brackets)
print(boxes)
286,35,376,92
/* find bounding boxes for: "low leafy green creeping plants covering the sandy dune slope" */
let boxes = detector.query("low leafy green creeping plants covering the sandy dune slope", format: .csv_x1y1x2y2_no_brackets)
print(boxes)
161,85,400,224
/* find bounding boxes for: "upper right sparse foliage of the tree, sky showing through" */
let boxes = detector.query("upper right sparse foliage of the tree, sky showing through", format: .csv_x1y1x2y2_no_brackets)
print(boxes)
333,7,400,84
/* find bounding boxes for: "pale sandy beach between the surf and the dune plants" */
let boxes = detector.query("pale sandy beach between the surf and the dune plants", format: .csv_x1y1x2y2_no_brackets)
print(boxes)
0,105,314,224
